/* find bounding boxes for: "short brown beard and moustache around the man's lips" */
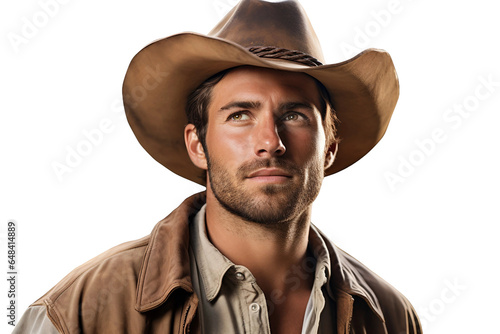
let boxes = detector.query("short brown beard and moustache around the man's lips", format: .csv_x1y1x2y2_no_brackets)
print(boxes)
207,156,324,224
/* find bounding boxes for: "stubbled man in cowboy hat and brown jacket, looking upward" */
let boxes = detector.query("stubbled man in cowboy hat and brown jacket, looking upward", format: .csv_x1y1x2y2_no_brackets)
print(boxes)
15,0,421,333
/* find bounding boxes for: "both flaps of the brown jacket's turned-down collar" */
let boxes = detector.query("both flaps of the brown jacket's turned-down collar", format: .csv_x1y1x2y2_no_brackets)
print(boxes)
136,192,384,321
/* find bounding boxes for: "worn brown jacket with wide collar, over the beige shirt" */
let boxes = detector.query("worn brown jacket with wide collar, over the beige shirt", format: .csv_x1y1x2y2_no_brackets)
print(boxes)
33,193,421,334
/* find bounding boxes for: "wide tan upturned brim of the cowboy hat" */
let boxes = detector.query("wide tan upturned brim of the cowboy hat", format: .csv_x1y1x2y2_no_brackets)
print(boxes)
123,33,399,185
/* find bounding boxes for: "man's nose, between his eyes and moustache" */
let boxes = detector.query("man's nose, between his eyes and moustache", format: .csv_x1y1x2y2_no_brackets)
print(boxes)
254,116,286,157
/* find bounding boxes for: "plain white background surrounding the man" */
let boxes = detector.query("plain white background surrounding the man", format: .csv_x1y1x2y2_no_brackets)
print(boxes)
0,0,500,333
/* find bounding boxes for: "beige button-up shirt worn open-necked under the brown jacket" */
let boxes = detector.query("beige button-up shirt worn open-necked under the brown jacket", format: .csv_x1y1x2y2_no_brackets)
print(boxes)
190,206,336,334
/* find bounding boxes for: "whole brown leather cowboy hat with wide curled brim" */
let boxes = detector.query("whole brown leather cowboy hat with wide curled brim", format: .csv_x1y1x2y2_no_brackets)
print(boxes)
123,0,399,185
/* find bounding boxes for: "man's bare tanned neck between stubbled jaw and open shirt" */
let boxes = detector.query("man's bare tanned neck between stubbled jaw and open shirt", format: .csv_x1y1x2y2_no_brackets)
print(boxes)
206,189,314,298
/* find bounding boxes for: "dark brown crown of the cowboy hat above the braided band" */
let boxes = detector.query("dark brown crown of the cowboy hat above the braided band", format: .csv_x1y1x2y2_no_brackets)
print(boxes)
208,0,324,62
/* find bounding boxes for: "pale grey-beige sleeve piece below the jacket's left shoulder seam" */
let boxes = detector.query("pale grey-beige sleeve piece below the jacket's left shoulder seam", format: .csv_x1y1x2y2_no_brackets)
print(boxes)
12,305,59,334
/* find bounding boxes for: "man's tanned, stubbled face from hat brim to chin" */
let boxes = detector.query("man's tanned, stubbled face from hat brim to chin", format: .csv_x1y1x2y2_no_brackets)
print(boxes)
202,67,325,224
